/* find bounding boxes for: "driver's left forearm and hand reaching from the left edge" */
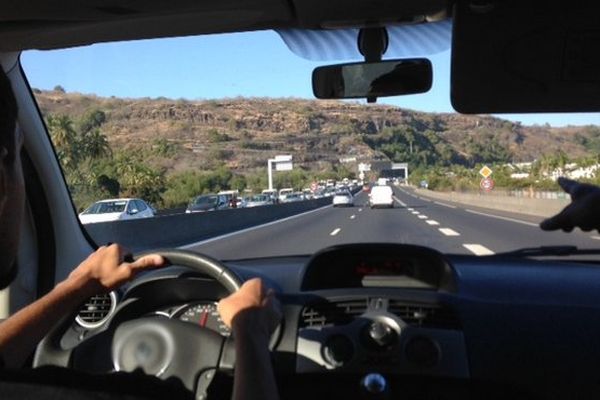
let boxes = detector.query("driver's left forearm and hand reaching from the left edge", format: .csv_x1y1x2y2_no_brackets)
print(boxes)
0,244,164,368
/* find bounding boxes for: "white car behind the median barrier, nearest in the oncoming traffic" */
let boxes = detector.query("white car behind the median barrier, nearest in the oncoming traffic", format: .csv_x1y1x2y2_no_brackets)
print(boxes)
79,199,154,224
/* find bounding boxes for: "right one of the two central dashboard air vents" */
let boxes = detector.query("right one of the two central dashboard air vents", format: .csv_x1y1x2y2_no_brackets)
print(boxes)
388,300,460,329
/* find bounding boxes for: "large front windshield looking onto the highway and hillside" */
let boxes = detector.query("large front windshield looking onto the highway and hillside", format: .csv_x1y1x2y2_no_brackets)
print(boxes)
21,31,600,259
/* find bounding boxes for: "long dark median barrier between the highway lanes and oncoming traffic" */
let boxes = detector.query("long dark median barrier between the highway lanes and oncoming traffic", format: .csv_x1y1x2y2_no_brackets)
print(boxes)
84,197,331,252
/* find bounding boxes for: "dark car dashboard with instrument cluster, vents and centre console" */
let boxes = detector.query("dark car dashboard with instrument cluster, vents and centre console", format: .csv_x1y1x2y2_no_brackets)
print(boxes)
52,244,600,399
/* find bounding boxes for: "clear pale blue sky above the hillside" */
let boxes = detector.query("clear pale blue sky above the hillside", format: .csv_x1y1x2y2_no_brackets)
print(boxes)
21,31,600,126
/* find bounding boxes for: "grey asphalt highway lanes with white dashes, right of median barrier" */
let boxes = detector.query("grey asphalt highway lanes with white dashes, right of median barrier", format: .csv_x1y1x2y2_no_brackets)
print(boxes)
183,187,600,260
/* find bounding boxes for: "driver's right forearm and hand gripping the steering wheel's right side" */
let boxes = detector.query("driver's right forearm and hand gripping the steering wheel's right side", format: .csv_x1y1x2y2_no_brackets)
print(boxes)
218,278,281,400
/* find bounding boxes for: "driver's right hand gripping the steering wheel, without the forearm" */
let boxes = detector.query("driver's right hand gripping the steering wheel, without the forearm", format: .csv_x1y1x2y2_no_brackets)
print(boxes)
217,278,281,335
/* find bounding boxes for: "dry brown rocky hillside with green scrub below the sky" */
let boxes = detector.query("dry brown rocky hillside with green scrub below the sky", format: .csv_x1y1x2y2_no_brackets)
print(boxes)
35,90,600,174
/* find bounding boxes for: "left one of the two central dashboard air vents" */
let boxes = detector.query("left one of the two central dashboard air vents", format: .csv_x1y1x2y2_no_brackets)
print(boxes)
300,298,367,328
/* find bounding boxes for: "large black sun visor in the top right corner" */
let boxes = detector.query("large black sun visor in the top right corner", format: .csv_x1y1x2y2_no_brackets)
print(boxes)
451,0,600,114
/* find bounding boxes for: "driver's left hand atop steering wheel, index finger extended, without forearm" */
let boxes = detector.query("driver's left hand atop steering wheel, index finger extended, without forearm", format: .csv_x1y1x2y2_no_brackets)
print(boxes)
66,244,165,299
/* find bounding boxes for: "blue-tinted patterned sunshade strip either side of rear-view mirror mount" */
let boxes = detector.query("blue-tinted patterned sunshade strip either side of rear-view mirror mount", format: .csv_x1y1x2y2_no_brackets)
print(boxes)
277,20,452,61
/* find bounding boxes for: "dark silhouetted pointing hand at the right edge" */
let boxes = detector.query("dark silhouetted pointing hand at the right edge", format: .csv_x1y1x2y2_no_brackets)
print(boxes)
540,177,600,232
